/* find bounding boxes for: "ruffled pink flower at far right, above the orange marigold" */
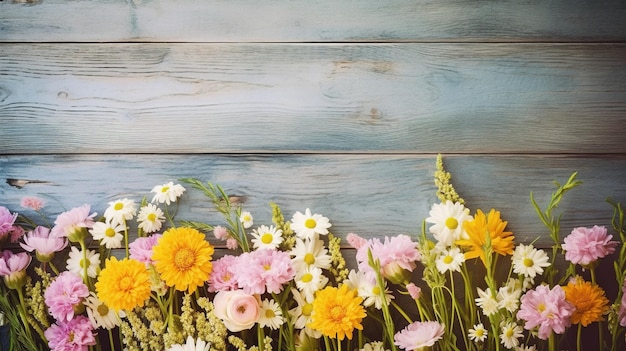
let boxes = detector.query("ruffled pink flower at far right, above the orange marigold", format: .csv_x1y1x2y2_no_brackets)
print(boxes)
562,225,618,266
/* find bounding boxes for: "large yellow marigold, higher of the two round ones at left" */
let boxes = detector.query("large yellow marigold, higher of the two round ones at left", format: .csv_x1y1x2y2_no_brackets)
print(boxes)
152,227,214,293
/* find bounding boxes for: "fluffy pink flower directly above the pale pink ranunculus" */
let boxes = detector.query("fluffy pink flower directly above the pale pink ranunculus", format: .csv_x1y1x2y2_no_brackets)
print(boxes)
235,249,296,294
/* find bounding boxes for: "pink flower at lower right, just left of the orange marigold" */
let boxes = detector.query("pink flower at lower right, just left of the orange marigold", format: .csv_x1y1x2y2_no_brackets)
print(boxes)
517,285,576,340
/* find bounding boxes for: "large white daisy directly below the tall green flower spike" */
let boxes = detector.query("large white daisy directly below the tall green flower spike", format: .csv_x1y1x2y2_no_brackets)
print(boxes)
426,200,472,246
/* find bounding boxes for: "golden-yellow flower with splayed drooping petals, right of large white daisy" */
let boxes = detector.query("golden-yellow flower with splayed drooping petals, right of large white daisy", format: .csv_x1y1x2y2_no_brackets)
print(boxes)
456,209,514,263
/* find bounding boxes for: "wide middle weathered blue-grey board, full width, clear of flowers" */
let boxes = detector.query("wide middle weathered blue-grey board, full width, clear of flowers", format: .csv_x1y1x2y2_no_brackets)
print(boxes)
0,43,626,154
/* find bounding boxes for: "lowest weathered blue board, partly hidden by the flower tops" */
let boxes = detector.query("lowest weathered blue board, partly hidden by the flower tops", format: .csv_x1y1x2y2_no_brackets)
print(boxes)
0,154,626,246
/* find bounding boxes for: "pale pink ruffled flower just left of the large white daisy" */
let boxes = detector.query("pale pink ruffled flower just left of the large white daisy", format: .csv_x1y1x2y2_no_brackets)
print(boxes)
356,234,421,284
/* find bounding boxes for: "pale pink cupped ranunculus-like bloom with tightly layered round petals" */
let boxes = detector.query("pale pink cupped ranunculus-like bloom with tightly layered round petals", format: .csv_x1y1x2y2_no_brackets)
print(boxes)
213,290,261,332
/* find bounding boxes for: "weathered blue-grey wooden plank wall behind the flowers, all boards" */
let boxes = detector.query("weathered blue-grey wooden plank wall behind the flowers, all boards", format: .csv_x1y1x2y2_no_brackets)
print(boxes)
0,0,626,253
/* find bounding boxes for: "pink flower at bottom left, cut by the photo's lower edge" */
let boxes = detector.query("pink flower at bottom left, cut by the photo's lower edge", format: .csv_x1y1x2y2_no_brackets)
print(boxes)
44,316,96,351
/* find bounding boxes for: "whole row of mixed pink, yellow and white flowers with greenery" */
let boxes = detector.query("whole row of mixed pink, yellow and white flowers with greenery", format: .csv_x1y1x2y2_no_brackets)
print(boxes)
0,157,626,351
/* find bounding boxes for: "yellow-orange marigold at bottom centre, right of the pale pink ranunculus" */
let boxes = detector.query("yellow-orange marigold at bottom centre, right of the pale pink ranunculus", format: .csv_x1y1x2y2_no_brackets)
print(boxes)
308,284,366,340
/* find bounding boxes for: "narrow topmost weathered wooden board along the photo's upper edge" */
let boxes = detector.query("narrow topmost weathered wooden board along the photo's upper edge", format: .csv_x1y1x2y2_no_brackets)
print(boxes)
0,0,626,42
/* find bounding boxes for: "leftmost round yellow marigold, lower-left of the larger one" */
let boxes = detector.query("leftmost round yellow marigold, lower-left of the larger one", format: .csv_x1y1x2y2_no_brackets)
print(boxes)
96,257,151,311
